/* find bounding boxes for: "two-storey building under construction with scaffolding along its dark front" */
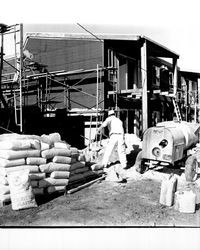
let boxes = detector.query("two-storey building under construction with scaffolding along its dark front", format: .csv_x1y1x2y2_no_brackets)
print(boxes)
0,22,200,147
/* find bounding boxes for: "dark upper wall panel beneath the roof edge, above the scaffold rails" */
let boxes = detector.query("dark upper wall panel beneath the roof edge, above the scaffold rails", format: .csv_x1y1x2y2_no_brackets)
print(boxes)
26,38,102,71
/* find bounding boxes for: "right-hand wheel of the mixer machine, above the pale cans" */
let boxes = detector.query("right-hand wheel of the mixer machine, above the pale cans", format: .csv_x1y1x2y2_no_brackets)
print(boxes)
185,155,198,182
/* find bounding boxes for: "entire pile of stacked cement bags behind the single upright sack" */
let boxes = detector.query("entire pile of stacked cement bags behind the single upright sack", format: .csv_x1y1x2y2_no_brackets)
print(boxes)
0,133,103,206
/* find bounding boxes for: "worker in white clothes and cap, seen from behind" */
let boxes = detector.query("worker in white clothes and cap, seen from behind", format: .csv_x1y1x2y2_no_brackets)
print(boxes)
97,110,127,180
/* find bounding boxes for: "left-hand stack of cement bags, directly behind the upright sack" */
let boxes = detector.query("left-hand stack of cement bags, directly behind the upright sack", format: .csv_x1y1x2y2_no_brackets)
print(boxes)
0,134,46,202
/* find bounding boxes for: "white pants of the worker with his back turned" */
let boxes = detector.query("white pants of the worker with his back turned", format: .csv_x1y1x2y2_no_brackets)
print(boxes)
102,134,127,168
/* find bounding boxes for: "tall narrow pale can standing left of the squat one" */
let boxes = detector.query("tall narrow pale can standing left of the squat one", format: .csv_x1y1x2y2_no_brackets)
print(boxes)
160,175,177,207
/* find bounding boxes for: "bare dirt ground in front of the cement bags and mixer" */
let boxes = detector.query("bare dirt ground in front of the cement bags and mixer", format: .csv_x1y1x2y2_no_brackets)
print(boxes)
0,165,200,227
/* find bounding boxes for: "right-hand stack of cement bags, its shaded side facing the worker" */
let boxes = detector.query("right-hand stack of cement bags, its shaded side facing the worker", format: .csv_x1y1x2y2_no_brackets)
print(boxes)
39,141,104,193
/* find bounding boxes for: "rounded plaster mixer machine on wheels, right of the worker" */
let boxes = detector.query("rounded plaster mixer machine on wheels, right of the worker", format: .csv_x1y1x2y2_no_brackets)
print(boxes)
140,121,200,181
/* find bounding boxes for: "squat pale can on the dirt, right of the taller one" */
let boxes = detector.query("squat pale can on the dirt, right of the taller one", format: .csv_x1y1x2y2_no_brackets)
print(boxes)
174,190,196,213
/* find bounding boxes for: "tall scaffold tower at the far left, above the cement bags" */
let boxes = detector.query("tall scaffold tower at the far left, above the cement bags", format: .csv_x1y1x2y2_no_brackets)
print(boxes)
0,24,25,132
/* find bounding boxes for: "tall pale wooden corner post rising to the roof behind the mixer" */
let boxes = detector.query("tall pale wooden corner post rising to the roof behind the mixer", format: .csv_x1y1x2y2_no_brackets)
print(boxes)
141,41,148,132
